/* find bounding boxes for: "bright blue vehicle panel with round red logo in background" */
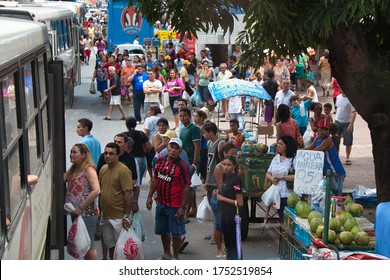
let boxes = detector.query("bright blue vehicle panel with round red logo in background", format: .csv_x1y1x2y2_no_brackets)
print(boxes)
107,1,154,52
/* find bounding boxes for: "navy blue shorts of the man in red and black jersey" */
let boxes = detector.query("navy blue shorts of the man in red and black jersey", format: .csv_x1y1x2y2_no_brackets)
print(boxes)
154,202,186,237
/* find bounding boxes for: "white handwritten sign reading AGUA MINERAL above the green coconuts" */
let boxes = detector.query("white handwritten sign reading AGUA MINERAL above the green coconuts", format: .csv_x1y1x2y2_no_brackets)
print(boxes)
294,150,325,194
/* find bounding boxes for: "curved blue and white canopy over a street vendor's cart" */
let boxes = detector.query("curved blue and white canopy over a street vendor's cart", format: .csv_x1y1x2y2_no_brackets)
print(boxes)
208,79,271,101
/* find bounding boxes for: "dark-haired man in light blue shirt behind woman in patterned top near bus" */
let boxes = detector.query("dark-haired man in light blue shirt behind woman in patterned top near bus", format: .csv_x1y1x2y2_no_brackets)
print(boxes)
76,118,102,166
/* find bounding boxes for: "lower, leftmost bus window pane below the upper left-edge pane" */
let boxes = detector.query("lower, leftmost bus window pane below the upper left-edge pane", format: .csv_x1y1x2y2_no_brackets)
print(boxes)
5,145,25,223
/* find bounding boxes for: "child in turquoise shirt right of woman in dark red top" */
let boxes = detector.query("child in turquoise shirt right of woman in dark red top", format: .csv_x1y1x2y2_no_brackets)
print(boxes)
290,95,312,136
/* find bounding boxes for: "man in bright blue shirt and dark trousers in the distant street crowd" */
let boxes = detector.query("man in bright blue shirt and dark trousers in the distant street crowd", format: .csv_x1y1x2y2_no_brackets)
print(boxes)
128,64,149,123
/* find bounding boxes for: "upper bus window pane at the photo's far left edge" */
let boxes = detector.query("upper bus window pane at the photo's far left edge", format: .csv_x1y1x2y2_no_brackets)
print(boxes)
0,74,18,148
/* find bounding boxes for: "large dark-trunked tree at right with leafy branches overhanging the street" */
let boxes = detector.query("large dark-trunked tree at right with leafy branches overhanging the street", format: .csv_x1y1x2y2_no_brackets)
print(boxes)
130,0,390,202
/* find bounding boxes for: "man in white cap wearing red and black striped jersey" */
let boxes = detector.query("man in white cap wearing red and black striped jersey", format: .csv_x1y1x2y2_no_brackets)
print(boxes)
146,138,191,260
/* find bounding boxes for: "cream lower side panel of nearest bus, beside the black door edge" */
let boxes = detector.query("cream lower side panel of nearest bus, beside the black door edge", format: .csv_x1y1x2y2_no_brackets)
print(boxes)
31,153,53,260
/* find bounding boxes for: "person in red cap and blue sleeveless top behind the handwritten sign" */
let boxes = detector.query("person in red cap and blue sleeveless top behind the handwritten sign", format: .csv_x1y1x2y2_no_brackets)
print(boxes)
305,118,346,195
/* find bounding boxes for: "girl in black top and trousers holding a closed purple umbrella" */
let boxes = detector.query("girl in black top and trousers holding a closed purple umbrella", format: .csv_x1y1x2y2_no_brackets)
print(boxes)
214,156,244,260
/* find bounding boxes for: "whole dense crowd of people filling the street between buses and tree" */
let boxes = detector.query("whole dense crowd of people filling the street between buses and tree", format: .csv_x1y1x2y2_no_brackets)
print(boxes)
65,38,357,260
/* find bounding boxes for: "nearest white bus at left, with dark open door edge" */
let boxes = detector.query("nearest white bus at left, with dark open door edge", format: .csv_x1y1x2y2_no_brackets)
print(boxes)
0,17,66,260
